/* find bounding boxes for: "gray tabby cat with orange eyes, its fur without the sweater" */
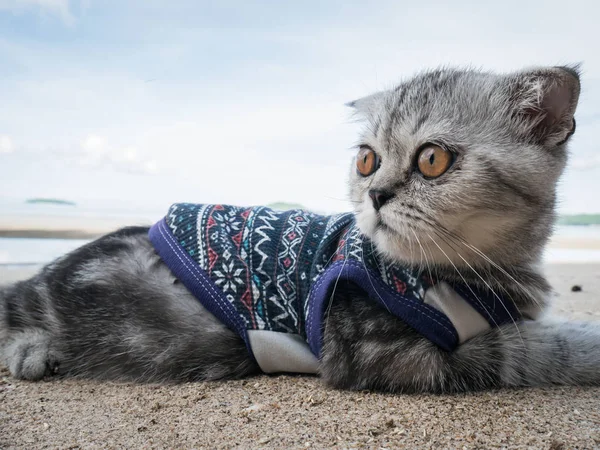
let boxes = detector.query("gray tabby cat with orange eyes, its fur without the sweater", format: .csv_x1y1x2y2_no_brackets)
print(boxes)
0,67,600,393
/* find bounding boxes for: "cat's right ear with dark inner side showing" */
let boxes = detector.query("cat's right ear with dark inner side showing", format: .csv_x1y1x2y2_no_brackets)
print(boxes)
511,66,580,147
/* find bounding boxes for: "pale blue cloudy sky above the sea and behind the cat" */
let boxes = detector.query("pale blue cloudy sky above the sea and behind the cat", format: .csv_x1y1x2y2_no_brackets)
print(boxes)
0,0,600,213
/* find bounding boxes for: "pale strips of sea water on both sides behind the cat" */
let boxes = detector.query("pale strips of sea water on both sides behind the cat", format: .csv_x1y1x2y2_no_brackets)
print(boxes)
0,199,600,268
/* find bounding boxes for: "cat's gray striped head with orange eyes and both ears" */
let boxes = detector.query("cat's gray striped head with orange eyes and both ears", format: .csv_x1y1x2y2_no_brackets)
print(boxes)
350,67,580,266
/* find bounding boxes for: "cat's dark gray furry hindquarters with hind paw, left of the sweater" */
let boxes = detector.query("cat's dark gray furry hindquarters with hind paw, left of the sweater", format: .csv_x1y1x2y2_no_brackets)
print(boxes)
0,228,258,382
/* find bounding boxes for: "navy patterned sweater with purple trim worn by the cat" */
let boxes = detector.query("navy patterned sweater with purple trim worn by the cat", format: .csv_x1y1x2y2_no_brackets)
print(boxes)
149,203,519,373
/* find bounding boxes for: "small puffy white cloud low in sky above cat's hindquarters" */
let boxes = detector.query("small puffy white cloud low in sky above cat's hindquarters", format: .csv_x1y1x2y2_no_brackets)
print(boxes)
78,134,159,175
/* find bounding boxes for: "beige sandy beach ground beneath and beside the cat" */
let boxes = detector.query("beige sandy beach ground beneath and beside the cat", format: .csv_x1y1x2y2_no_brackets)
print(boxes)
0,265,600,450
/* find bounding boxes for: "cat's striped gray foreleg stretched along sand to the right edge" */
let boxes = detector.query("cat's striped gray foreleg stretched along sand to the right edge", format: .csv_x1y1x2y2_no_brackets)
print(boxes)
320,285,600,393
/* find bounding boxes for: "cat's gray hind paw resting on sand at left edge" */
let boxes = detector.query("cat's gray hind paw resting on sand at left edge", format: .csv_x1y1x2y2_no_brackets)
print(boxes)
2,330,60,381
